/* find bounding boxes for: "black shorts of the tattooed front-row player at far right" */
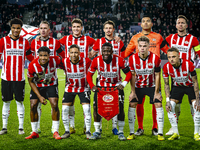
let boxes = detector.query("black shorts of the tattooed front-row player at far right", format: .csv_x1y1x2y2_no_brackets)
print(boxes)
170,86,196,104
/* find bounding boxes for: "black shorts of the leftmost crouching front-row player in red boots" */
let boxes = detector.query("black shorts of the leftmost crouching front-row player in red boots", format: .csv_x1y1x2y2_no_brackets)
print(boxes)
30,85,58,100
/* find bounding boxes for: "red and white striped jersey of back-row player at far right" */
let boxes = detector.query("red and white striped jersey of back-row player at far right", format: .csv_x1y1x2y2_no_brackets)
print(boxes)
165,33,200,61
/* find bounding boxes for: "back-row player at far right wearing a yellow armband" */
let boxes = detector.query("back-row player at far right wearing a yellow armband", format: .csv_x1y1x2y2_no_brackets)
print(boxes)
164,15,200,135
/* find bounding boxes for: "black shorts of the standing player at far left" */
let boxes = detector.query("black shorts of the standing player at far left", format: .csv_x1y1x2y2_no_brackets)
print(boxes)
1,79,25,101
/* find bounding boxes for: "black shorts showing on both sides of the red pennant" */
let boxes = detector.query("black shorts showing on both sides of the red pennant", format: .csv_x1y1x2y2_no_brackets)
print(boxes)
93,90,124,113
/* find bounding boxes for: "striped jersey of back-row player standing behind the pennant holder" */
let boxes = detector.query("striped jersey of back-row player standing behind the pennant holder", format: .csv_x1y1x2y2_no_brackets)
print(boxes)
93,37,125,58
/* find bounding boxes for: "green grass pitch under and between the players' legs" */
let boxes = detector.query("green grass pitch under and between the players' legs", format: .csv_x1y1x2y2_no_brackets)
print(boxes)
0,69,200,149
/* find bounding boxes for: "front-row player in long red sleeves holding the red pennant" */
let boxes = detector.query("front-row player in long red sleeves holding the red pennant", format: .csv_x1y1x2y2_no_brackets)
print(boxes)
87,42,131,140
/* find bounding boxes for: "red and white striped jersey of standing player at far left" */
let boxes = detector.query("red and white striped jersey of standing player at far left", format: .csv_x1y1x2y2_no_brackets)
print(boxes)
0,36,30,81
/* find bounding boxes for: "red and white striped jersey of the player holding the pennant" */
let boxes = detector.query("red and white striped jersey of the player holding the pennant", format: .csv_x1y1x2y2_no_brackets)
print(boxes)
89,54,127,87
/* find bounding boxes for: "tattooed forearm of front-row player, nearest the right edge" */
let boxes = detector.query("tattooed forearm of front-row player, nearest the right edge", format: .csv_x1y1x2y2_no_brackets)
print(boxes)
192,75,200,111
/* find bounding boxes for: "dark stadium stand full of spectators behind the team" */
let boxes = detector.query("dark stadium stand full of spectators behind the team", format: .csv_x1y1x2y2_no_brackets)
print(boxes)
0,0,200,59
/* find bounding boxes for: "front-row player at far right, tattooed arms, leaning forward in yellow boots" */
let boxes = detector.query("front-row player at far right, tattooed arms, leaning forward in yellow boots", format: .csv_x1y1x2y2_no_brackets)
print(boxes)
163,48,200,141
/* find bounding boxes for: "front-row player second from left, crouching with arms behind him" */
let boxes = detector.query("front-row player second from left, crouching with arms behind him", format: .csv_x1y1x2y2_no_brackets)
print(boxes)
61,44,91,139
